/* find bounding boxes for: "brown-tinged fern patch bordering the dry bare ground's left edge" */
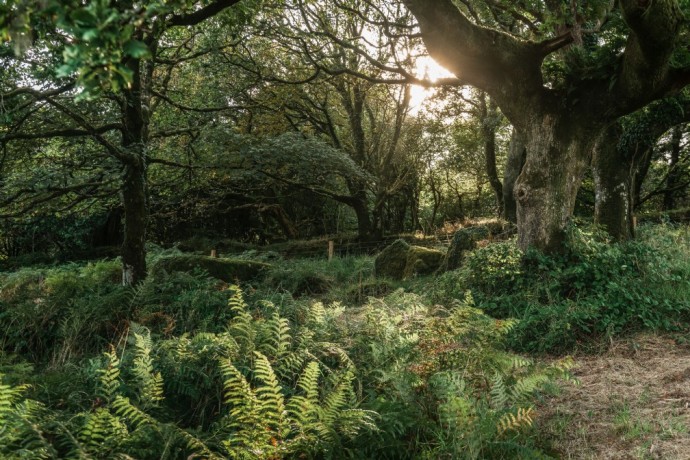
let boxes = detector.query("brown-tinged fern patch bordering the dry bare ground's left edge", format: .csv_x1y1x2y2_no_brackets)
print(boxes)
340,290,571,458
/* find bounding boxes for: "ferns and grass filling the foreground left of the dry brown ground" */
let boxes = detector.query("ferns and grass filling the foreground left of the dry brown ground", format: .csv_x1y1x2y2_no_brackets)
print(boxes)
0,258,570,459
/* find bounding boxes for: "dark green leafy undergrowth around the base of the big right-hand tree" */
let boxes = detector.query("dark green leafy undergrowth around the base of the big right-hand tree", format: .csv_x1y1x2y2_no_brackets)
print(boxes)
430,225,690,353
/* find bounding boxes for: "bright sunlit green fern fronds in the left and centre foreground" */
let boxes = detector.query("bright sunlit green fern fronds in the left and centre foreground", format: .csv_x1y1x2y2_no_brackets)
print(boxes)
0,290,375,459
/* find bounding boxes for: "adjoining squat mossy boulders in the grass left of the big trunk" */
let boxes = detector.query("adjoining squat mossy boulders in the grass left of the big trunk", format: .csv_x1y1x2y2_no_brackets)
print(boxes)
374,240,444,280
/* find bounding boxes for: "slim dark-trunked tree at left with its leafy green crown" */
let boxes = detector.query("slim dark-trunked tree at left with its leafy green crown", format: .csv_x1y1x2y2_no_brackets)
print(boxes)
0,0,250,284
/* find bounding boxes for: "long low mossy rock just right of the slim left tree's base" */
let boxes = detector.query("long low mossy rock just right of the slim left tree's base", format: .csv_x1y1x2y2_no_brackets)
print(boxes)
151,254,271,283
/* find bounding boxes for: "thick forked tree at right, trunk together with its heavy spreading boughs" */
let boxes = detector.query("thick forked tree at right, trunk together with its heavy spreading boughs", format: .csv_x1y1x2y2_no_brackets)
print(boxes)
404,0,687,252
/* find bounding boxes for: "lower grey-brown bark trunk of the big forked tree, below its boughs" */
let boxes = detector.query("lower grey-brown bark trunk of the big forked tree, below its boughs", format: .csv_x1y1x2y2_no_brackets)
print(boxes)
515,116,596,252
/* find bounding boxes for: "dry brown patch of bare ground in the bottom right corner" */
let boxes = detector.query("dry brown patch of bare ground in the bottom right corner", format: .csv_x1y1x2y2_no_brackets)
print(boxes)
539,333,690,460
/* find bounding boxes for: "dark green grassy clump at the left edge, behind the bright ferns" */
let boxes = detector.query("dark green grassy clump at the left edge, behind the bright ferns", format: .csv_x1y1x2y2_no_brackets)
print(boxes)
0,261,130,364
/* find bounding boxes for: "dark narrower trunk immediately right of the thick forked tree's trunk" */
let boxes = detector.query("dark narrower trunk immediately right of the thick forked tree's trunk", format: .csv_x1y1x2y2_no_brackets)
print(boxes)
592,123,634,241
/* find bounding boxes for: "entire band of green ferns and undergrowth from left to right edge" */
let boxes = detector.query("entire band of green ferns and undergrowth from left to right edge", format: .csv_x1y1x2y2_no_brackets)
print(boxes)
0,226,690,459
